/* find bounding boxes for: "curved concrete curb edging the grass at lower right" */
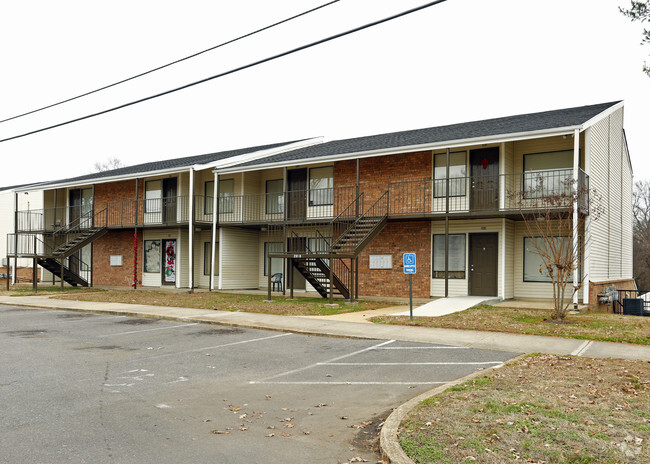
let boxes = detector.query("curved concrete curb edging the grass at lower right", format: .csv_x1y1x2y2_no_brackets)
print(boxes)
379,354,527,464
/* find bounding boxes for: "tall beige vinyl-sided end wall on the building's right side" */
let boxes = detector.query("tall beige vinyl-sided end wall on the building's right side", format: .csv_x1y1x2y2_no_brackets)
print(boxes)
587,108,632,282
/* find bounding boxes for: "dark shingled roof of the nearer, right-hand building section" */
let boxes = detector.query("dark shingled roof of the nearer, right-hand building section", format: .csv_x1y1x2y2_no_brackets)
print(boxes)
233,101,619,167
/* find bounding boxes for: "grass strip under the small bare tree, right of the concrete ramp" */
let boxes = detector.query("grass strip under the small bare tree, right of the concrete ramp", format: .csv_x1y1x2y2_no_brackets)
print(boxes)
371,305,650,345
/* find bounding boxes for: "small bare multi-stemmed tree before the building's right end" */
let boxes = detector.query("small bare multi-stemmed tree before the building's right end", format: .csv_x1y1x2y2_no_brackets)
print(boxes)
508,173,601,320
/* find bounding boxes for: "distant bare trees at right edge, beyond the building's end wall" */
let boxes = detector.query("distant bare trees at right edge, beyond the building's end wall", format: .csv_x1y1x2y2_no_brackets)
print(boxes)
632,180,650,290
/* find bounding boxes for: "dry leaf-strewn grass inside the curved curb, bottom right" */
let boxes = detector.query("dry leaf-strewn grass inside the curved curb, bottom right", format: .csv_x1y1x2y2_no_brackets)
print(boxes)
399,355,650,464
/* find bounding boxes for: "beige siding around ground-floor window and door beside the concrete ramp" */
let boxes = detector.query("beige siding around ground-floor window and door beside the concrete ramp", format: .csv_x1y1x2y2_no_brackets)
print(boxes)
428,218,511,296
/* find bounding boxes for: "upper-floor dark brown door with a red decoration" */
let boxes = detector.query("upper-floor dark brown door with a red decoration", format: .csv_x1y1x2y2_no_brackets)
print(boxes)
469,147,499,211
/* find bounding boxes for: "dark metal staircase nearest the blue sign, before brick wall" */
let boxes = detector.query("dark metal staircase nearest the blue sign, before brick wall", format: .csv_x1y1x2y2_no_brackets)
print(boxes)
291,192,388,299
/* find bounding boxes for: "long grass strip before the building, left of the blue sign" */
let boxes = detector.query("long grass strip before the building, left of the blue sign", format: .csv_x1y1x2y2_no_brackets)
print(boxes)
17,287,391,316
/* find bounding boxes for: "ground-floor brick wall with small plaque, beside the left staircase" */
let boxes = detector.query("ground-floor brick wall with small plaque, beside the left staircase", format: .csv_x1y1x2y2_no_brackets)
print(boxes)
93,230,142,287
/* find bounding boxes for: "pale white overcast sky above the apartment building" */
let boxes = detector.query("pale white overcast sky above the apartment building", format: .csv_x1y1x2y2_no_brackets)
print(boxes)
0,0,650,186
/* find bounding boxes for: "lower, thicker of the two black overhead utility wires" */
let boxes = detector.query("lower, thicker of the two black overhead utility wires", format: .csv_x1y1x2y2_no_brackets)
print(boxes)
0,0,447,143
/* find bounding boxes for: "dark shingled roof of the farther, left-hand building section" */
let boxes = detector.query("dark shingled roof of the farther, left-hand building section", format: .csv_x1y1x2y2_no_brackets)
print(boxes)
33,140,300,187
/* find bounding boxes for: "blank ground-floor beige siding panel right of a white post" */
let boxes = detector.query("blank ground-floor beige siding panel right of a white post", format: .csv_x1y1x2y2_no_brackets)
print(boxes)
220,227,259,290
